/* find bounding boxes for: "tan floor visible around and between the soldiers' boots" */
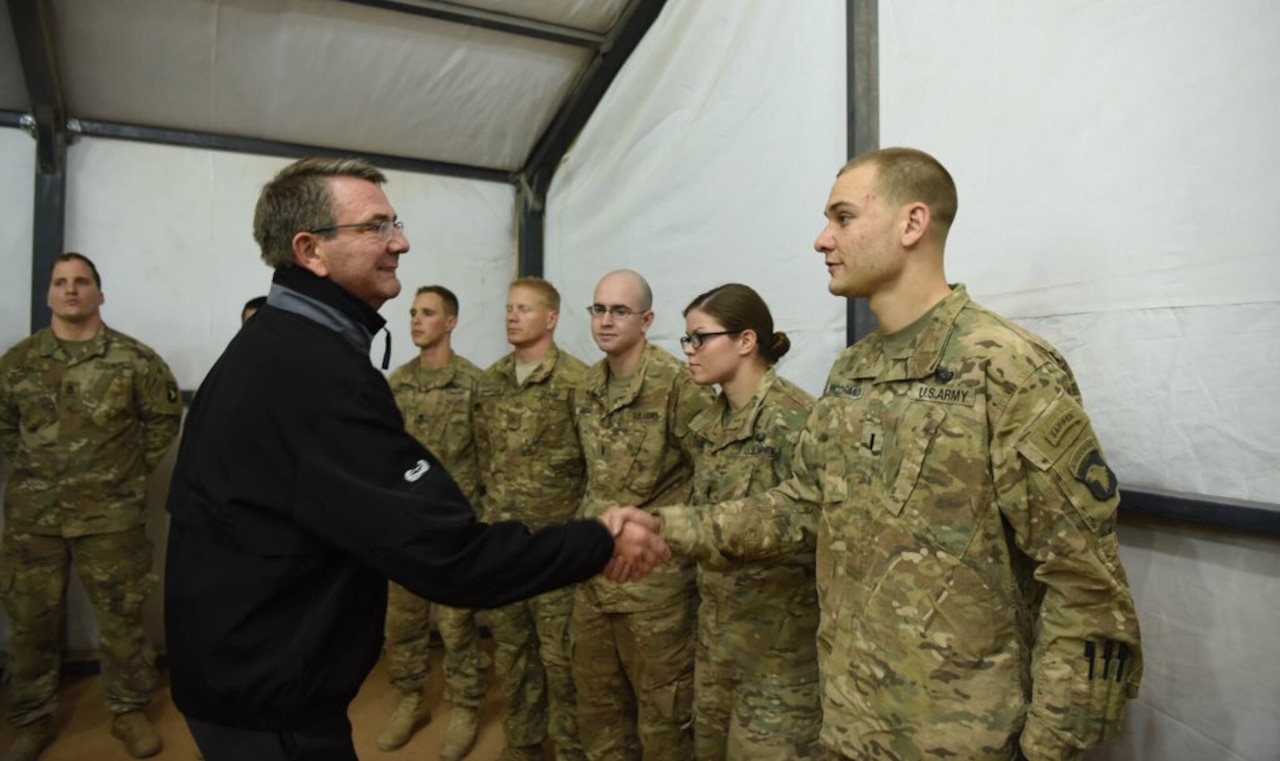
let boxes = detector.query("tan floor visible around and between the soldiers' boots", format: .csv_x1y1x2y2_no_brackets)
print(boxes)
0,642,529,761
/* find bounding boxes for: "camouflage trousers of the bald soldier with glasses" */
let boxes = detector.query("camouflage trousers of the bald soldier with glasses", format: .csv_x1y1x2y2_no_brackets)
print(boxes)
572,590,698,761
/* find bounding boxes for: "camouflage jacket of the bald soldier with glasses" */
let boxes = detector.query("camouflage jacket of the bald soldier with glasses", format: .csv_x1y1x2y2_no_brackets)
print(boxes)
577,344,712,613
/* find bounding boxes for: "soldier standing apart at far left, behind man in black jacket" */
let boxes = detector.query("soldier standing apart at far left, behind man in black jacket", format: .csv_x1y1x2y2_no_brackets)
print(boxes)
0,253,182,761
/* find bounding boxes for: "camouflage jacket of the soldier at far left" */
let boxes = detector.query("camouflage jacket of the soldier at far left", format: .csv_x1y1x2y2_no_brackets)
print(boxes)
0,326,182,537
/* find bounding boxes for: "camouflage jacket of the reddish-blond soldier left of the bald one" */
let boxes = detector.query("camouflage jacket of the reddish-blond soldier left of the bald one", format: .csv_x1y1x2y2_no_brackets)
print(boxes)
475,347,586,530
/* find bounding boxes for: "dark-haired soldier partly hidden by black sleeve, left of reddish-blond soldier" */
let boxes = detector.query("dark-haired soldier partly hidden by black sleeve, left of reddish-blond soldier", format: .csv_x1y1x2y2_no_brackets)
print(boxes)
378,285,488,761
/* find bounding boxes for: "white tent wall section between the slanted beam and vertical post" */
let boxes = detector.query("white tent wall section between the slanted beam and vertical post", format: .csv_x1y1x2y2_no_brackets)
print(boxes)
544,0,846,393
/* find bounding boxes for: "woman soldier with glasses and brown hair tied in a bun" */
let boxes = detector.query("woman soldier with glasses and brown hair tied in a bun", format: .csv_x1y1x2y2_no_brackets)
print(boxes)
671,283,822,761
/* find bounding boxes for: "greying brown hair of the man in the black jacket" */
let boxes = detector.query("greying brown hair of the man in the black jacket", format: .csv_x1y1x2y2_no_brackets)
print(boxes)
253,157,387,270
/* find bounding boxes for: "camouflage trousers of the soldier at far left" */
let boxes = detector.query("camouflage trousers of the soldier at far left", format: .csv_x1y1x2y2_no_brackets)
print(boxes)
0,527,157,726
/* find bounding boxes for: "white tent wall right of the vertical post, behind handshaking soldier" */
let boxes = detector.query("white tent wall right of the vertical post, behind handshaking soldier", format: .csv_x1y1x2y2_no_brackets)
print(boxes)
879,0,1280,761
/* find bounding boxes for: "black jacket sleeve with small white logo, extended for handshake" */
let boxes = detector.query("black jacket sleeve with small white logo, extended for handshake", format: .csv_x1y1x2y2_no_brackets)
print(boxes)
293,384,613,608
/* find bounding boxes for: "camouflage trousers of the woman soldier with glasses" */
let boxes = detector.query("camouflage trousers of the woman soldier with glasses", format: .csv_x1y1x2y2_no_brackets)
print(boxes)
694,639,826,761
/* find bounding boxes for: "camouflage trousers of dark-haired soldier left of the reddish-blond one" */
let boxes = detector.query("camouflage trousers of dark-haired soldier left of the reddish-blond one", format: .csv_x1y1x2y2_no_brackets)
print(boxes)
384,582,489,709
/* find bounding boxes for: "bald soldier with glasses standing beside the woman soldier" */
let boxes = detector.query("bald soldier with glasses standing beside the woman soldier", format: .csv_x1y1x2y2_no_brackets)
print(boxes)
573,270,712,761
